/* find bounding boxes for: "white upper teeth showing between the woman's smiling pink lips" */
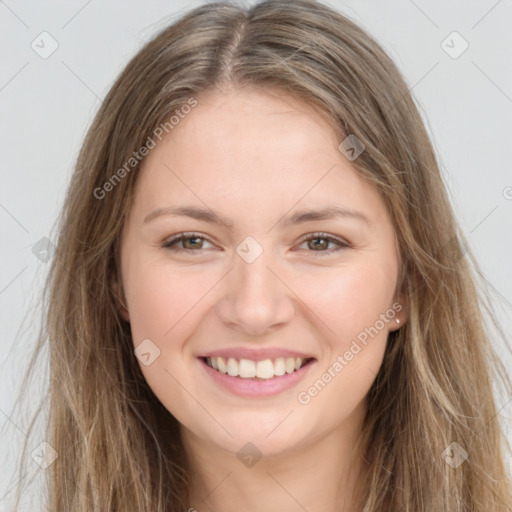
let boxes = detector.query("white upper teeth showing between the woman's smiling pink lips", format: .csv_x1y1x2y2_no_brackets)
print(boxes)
200,357,314,380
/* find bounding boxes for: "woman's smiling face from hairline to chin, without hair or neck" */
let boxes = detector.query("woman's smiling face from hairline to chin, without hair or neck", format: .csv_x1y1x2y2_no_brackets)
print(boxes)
121,86,405,455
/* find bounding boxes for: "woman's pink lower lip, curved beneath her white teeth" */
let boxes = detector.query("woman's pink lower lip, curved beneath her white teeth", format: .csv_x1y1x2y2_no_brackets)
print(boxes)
199,359,316,397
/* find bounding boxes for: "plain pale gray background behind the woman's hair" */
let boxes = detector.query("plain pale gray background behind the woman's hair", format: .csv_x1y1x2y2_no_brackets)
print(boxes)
0,0,512,511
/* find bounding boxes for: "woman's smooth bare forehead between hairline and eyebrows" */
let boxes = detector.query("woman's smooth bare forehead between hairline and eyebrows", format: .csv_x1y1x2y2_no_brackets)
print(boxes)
130,90,386,226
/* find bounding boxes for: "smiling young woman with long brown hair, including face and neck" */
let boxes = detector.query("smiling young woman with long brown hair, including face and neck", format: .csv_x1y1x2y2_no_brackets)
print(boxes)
9,0,511,512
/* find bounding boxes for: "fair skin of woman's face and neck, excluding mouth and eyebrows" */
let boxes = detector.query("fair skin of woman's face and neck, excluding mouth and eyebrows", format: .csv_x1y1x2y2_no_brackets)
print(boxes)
121,90,406,512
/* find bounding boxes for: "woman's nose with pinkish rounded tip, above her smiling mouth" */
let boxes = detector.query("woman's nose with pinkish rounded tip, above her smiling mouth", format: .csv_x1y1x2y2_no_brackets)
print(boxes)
216,243,296,336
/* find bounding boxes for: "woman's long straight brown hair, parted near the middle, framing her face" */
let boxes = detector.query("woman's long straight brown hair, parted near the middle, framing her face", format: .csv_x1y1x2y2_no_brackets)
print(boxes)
9,0,512,512
